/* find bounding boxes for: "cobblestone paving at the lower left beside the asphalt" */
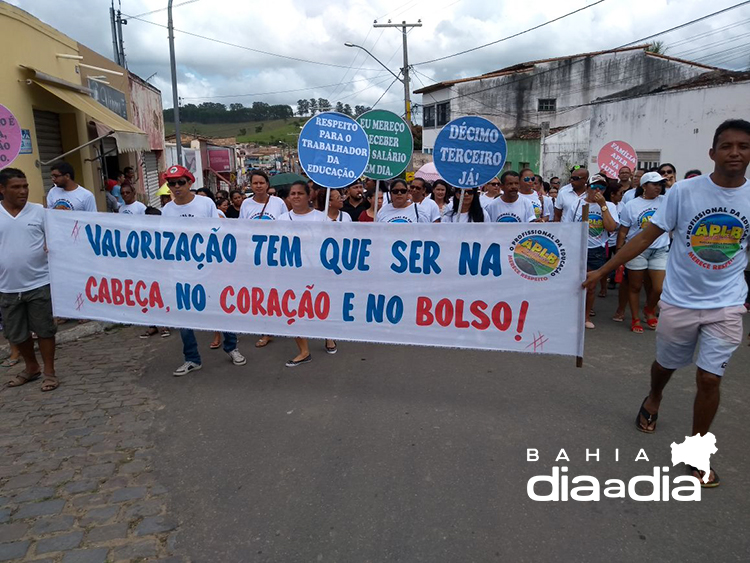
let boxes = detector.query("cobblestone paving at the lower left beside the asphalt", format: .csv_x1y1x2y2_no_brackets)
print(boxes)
0,323,184,563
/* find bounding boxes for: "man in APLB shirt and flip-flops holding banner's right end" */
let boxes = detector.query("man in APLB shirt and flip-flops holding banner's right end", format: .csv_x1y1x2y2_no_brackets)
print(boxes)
584,119,750,487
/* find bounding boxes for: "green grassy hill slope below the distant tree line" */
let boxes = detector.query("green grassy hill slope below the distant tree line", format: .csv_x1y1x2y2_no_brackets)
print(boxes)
164,117,308,145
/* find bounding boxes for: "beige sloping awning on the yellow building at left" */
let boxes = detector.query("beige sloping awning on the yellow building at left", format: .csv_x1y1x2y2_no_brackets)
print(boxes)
34,80,151,152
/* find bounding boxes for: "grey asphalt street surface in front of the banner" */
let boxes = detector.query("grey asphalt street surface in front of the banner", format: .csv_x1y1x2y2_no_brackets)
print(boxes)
142,295,750,563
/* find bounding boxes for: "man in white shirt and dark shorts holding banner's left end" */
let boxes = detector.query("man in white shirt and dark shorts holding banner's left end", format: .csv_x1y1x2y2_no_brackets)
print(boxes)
0,168,60,391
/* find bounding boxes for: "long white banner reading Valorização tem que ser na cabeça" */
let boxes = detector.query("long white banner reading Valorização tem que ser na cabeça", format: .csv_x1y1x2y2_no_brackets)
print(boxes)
46,210,586,356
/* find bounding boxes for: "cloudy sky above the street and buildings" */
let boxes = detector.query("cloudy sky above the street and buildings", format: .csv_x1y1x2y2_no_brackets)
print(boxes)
11,0,750,113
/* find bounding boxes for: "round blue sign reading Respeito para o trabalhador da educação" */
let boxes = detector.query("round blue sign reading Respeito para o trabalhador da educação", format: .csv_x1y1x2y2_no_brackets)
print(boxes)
297,112,370,188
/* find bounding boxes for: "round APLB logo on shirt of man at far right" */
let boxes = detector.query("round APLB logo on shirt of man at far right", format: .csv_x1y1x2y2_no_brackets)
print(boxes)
687,212,748,270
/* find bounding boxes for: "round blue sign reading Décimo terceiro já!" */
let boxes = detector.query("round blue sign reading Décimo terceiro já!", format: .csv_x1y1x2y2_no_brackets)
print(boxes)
434,116,508,189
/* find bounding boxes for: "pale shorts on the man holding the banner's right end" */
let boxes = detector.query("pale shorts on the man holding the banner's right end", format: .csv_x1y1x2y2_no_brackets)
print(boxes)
656,302,746,376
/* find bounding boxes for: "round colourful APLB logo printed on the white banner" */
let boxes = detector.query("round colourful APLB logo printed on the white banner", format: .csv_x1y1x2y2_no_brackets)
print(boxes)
508,230,565,281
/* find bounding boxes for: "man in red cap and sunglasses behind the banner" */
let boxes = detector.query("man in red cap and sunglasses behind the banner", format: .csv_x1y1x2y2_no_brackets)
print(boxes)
161,166,247,377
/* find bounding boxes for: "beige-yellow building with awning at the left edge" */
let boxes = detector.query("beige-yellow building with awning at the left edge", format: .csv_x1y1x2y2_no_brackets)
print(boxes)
0,1,154,210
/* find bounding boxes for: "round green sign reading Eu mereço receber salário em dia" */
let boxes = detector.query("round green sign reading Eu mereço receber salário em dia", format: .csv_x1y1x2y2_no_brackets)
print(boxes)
357,109,414,180
